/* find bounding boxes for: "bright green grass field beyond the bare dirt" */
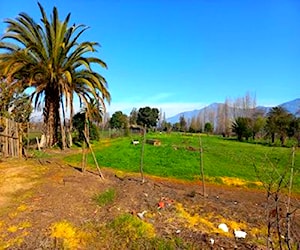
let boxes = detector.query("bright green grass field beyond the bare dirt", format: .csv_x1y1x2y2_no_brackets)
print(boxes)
66,133,300,193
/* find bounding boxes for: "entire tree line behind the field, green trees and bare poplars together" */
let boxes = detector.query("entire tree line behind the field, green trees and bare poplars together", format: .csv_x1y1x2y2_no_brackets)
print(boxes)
107,93,300,146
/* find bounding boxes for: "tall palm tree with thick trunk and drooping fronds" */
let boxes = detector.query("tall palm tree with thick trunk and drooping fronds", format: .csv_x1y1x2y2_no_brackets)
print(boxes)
0,3,110,146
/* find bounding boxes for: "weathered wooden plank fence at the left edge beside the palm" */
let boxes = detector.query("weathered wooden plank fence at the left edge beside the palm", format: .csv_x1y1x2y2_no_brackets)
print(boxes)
0,117,22,157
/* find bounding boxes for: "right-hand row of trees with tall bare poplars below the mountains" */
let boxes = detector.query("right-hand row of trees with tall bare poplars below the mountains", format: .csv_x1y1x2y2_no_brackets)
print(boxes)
154,93,300,145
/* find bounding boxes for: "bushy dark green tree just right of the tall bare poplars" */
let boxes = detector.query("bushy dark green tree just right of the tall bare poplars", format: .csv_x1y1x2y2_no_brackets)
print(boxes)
232,117,252,141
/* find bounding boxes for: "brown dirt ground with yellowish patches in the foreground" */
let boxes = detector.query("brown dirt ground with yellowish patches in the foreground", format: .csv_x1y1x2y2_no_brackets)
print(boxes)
0,151,300,249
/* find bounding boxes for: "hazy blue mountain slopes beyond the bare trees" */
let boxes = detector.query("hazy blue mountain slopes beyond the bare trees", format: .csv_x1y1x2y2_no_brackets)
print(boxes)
167,98,300,124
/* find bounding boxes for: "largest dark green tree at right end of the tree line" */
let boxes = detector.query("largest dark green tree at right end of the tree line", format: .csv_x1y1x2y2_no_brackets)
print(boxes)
265,106,293,146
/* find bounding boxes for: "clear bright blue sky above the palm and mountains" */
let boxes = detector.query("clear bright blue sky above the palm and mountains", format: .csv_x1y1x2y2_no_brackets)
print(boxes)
0,0,300,118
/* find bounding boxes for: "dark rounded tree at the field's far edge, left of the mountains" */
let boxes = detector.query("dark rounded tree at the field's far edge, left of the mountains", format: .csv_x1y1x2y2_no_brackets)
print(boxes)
137,107,159,128
